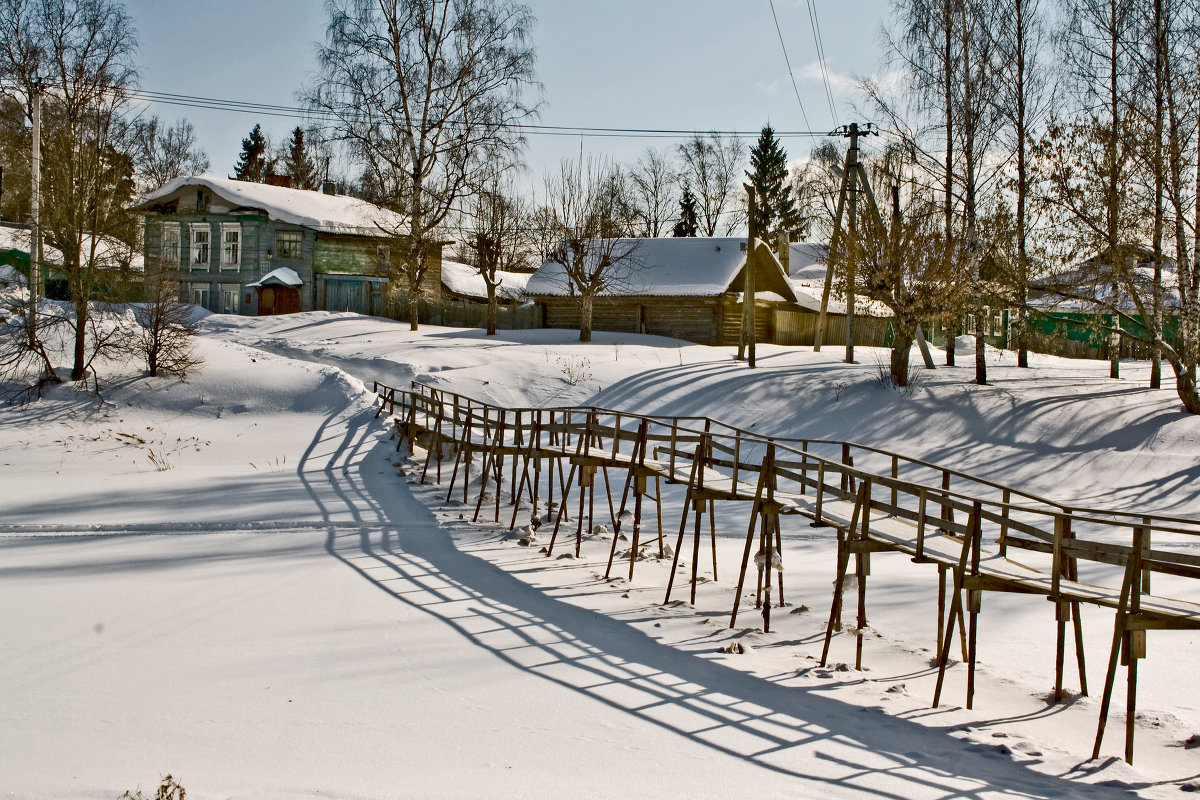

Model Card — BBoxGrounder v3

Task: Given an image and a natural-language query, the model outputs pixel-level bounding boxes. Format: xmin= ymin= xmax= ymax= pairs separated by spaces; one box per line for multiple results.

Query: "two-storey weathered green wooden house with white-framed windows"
xmin=133 ymin=175 xmax=442 ymax=314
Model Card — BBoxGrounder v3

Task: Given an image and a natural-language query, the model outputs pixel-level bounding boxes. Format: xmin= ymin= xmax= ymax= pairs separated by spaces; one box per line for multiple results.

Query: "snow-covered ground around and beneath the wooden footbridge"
xmin=0 ymin=313 xmax=1200 ymax=799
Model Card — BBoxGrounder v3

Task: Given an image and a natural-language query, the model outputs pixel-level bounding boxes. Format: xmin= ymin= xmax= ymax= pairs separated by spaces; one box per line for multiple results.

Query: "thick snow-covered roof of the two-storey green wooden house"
xmin=133 ymin=175 xmax=404 ymax=236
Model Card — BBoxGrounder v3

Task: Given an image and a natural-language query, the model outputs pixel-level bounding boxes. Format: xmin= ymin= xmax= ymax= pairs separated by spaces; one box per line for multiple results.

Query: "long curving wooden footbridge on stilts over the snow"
xmin=374 ymin=381 xmax=1200 ymax=763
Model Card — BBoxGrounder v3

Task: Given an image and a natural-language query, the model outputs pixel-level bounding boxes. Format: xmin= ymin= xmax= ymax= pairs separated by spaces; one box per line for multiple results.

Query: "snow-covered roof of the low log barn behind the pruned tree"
xmin=528 ymin=237 xmax=792 ymax=300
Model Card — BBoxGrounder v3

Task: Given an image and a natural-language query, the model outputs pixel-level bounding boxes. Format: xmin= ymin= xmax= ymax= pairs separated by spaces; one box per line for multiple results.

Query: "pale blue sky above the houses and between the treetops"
xmin=126 ymin=0 xmax=888 ymax=183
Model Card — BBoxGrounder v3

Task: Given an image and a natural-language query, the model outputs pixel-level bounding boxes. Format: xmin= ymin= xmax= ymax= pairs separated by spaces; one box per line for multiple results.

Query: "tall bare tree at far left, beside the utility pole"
xmin=0 ymin=0 xmax=137 ymax=380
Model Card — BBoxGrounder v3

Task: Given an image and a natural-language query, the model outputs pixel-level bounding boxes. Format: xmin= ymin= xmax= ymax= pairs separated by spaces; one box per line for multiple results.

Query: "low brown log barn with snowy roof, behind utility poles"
xmin=527 ymin=237 xmax=797 ymax=345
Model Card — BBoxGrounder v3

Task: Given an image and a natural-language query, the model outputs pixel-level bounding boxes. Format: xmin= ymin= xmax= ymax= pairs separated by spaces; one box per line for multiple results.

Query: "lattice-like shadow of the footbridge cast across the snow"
xmin=309 ymin=444 xmax=1142 ymax=798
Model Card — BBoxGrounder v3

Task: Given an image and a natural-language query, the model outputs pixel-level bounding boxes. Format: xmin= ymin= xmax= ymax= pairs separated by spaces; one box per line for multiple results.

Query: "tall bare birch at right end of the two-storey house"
xmin=302 ymin=0 xmax=538 ymax=330
